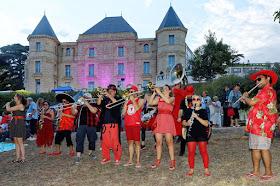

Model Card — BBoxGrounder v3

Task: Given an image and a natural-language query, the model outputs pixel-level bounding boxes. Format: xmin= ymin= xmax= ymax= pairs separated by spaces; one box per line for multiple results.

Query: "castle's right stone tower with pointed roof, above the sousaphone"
xmin=156 ymin=6 xmax=188 ymax=81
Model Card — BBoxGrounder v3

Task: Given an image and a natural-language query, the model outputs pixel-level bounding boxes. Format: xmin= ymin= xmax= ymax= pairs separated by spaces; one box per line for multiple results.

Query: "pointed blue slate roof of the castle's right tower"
xmin=158 ymin=6 xmax=185 ymax=30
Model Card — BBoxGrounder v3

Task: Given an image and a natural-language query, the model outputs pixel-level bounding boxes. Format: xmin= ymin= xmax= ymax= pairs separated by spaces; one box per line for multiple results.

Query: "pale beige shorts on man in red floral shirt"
xmin=249 ymin=133 xmax=271 ymax=150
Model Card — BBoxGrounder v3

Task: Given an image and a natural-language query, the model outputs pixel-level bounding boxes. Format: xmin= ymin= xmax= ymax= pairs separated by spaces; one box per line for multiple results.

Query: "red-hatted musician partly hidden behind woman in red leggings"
xmin=177 ymin=85 xmax=194 ymax=156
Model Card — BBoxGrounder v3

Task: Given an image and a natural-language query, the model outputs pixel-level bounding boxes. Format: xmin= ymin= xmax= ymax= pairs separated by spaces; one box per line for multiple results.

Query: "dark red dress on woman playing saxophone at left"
xmin=36 ymin=113 xmax=54 ymax=147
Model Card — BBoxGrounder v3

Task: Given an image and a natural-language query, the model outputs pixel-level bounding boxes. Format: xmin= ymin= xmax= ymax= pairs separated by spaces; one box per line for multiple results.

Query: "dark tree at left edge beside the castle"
xmin=0 ymin=44 xmax=29 ymax=90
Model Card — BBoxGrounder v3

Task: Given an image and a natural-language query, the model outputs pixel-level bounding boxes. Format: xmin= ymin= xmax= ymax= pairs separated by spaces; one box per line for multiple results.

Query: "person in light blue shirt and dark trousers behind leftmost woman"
xmin=26 ymin=97 xmax=38 ymax=141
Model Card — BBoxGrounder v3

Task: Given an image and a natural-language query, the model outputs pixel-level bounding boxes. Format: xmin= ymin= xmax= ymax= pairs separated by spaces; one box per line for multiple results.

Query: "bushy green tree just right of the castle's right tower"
xmin=190 ymin=31 xmax=244 ymax=82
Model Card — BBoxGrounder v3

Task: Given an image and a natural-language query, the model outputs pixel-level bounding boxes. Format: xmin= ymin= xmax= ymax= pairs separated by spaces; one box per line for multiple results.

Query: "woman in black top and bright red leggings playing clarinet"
xmin=182 ymin=95 xmax=210 ymax=176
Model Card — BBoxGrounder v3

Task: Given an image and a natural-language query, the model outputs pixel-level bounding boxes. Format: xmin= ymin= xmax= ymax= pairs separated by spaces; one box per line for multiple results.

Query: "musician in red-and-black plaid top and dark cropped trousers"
xmin=71 ymin=93 xmax=98 ymax=163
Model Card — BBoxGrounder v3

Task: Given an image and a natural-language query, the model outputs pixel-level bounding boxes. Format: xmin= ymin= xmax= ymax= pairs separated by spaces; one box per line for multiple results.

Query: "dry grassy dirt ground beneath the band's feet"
xmin=0 ymin=127 xmax=280 ymax=186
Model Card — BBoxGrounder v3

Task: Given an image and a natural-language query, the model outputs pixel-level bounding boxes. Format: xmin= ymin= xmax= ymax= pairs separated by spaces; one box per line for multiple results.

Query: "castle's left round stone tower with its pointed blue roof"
xmin=24 ymin=15 xmax=60 ymax=93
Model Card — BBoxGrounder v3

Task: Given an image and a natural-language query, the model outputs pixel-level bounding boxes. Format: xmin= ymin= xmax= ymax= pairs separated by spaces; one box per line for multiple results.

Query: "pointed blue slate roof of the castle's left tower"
xmin=31 ymin=15 xmax=58 ymax=40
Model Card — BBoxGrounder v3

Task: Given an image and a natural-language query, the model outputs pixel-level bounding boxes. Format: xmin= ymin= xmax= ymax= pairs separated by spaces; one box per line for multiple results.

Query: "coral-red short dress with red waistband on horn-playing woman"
xmin=153 ymin=98 xmax=176 ymax=136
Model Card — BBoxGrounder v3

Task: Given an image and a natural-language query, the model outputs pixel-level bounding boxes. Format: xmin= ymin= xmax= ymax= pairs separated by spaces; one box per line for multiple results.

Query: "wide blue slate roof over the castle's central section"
xmin=83 ymin=16 xmax=137 ymax=36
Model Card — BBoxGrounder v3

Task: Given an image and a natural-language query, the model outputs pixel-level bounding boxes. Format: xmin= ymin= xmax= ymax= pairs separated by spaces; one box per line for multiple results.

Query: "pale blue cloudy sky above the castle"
xmin=0 ymin=0 xmax=280 ymax=63
